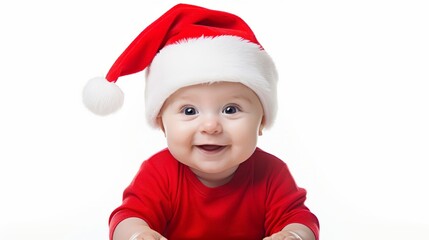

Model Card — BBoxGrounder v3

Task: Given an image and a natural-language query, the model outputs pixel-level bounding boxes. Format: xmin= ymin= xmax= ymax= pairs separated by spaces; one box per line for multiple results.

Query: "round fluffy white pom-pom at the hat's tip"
xmin=82 ymin=77 xmax=124 ymax=116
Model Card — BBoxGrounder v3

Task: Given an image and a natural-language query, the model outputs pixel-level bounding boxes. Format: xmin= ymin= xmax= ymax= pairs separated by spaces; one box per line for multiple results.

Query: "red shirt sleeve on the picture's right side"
xmin=265 ymin=158 xmax=319 ymax=239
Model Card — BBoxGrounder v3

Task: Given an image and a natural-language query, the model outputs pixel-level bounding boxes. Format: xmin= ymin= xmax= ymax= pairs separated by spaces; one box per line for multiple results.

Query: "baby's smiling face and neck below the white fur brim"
xmin=158 ymin=82 xmax=263 ymax=186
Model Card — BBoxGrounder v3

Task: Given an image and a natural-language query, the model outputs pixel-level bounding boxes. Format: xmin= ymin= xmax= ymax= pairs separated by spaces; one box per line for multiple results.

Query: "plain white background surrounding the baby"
xmin=0 ymin=0 xmax=429 ymax=240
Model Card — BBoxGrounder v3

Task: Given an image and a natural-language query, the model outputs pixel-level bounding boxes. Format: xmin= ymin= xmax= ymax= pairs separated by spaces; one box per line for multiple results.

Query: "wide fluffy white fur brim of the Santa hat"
xmin=145 ymin=36 xmax=277 ymax=127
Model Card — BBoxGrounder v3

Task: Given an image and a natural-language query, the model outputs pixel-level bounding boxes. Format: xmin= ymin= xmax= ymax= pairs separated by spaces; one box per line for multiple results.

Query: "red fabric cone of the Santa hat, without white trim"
xmin=106 ymin=4 xmax=259 ymax=82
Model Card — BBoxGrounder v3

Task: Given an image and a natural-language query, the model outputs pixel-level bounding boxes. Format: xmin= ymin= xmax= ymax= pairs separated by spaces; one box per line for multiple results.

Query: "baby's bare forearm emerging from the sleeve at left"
xmin=113 ymin=217 xmax=167 ymax=240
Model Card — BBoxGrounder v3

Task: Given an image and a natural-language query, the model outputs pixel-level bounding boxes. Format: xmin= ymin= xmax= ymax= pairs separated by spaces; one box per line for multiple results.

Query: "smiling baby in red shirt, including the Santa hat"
xmin=83 ymin=4 xmax=319 ymax=240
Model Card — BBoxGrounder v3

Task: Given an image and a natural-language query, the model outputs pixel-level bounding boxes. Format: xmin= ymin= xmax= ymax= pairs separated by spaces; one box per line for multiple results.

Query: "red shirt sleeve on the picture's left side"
xmin=109 ymin=155 xmax=176 ymax=239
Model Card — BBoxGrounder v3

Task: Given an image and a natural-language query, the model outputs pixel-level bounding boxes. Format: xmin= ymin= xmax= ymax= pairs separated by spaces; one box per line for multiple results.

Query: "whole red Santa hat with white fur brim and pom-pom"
xmin=83 ymin=4 xmax=277 ymax=127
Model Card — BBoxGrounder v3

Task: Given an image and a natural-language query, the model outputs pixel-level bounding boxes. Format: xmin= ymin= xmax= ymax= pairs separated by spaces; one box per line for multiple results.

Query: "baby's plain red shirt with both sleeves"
xmin=109 ymin=149 xmax=319 ymax=240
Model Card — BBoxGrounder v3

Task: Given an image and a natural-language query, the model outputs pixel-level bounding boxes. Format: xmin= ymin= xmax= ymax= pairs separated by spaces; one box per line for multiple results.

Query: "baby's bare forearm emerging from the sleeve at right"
xmin=263 ymin=223 xmax=315 ymax=240
